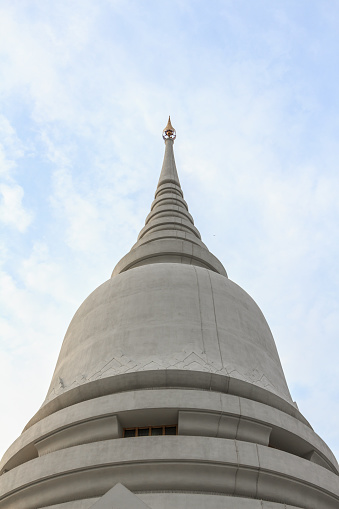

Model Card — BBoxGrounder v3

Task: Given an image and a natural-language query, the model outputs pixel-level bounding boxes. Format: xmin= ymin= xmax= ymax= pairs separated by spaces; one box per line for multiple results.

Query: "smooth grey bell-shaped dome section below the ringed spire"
xmin=45 ymin=263 xmax=292 ymax=403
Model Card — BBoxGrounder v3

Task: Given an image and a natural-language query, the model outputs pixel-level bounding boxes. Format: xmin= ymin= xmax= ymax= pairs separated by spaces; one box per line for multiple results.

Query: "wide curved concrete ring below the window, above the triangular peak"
xmin=0 ymin=436 xmax=339 ymax=509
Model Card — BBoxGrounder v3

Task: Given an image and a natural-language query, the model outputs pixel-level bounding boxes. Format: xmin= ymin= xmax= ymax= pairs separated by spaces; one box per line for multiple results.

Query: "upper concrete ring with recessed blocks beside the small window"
xmin=0 ymin=389 xmax=338 ymax=472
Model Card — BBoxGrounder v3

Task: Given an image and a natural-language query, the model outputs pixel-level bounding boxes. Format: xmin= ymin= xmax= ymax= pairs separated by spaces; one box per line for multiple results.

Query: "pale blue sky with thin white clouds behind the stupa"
xmin=0 ymin=0 xmax=339 ymax=458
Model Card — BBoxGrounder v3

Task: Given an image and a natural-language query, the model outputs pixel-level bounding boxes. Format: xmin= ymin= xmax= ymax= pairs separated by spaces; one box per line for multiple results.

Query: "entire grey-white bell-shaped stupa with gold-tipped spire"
xmin=0 ymin=120 xmax=339 ymax=509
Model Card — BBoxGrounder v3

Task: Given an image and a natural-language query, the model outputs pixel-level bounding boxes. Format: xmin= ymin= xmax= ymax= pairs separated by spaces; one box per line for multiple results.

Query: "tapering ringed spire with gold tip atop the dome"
xmin=112 ymin=117 xmax=227 ymax=277
